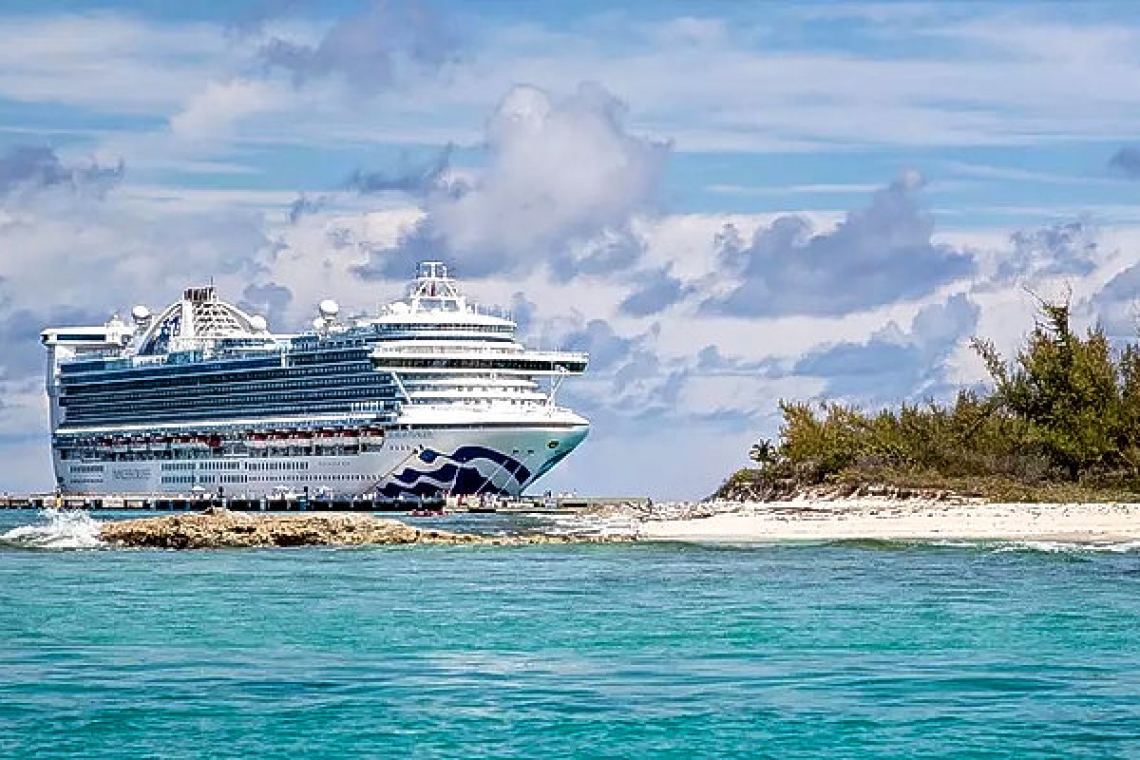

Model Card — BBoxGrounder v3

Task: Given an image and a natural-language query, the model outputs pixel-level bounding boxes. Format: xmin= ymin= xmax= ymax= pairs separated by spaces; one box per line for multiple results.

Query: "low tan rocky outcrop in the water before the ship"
xmin=99 ymin=508 xmax=634 ymax=549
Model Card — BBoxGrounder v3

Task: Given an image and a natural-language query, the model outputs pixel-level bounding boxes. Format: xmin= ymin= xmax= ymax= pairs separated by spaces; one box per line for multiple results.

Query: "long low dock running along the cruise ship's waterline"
xmin=0 ymin=493 xmax=650 ymax=514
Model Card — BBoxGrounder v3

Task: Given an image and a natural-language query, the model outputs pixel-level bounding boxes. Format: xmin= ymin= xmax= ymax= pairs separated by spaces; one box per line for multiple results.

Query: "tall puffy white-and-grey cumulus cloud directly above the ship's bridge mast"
xmin=358 ymin=83 xmax=669 ymax=278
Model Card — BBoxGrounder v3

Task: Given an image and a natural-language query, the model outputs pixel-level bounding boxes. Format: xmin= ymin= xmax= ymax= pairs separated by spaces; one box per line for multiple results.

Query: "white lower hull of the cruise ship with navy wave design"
xmin=55 ymin=418 xmax=589 ymax=498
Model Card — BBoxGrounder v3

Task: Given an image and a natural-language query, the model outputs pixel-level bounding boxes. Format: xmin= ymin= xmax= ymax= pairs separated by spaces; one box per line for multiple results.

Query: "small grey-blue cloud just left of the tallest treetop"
xmin=791 ymin=293 xmax=982 ymax=404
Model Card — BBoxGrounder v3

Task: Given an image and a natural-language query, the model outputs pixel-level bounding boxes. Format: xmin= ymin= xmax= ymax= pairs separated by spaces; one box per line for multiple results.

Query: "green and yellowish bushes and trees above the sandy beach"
xmin=717 ymin=302 xmax=1140 ymax=501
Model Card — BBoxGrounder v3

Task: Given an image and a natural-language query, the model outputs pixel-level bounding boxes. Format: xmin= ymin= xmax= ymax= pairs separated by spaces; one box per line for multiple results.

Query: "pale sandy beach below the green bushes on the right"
xmin=638 ymin=499 xmax=1140 ymax=544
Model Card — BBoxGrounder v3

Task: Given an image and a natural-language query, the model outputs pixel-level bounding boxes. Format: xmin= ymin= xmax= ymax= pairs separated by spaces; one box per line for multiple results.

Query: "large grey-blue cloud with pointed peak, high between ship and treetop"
xmin=702 ymin=172 xmax=975 ymax=317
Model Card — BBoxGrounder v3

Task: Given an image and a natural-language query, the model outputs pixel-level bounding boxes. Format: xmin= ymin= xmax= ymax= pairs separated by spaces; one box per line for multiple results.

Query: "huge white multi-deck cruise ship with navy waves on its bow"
xmin=41 ymin=262 xmax=589 ymax=499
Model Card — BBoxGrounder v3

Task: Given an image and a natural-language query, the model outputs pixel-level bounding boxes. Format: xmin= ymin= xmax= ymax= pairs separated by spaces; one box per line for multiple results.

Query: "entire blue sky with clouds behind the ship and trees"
xmin=0 ymin=0 xmax=1140 ymax=499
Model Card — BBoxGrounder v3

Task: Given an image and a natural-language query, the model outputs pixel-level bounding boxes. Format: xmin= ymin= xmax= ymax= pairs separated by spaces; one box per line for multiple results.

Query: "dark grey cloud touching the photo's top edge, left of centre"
xmin=259 ymin=0 xmax=459 ymax=92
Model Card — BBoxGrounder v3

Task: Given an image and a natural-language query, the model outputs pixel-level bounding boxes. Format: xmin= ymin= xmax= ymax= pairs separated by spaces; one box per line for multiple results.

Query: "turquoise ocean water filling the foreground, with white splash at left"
xmin=0 ymin=512 xmax=1140 ymax=760
